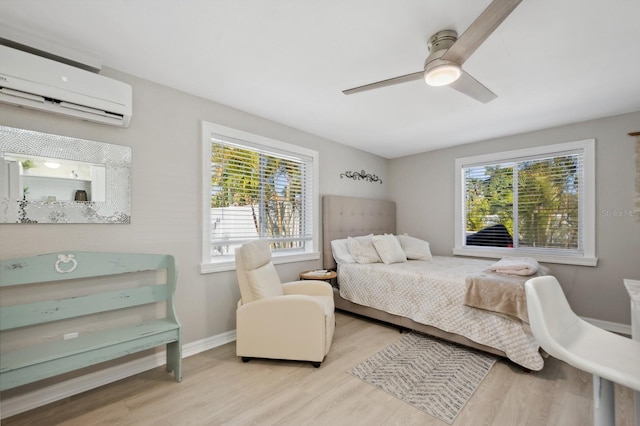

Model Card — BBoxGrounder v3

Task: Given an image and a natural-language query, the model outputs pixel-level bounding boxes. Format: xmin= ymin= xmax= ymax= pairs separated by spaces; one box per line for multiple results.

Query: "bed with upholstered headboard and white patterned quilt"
xmin=322 ymin=195 xmax=548 ymax=371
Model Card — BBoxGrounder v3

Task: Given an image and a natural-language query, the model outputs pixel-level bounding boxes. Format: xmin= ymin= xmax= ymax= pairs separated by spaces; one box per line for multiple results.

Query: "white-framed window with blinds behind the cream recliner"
xmin=201 ymin=122 xmax=319 ymax=272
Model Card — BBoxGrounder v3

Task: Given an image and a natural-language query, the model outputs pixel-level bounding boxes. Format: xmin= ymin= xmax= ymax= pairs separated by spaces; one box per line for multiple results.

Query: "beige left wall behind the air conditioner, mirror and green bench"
xmin=0 ymin=66 xmax=389 ymax=343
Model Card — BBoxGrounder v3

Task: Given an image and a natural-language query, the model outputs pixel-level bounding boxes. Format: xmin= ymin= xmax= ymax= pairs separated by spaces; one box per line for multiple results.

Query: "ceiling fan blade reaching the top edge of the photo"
xmin=441 ymin=0 xmax=522 ymax=65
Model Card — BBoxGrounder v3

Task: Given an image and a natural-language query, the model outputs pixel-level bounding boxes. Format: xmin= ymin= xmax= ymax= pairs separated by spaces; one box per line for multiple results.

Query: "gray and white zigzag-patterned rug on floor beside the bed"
xmin=348 ymin=332 xmax=497 ymax=424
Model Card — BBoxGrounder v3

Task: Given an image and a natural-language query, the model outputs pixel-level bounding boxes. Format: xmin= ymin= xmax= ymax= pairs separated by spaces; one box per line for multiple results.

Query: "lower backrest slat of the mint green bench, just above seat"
xmin=0 ymin=284 xmax=172 ymax=330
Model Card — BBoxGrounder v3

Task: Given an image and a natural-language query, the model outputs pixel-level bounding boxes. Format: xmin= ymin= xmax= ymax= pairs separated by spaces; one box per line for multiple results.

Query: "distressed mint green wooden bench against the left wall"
xmin=0 ymin=252 xmax=182 ymax=390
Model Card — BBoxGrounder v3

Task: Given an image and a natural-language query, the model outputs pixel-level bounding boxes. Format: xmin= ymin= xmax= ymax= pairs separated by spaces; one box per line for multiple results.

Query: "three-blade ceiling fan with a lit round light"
xmin=342 ymin=0 xmax=522 ymax=103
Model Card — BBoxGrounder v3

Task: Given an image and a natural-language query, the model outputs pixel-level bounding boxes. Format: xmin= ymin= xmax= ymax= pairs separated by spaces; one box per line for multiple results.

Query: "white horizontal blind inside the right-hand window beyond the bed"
xmin=464 ymin=153 xmax=583 ymax=253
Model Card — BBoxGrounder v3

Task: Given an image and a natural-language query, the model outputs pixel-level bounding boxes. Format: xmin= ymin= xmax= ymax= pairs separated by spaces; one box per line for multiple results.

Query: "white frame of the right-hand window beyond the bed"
xmin=453 ymin=139 xmax=598 ymax=266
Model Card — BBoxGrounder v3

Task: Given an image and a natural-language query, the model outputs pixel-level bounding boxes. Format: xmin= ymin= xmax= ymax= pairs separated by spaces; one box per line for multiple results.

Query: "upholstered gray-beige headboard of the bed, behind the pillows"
xmin=322 ymin=195 xmax=396 ymax=269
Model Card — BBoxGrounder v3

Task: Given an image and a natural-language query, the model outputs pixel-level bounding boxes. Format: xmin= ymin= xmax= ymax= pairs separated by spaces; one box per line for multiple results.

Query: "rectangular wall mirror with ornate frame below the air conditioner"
xmin=0 ymin=126 xmax=131 ymax=223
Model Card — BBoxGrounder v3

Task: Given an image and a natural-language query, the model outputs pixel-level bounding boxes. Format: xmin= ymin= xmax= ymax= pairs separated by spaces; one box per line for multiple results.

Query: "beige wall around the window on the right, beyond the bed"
xmin=389 ymin=112 xmax=640 ymax=324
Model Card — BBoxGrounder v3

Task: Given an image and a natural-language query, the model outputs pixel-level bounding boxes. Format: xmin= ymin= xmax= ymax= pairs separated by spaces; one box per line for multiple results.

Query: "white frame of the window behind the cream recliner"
xmin=200 ymin=120 xmax=320 ymax=274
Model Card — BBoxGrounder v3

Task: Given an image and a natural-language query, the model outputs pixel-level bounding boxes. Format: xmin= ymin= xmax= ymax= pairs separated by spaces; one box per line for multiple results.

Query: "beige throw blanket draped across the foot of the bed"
xmin=464 ymin=266 xmax=549 ymax=324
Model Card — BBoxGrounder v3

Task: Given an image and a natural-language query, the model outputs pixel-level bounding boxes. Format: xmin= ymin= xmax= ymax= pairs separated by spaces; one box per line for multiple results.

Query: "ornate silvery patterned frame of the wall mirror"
xmin=0 ymin=126 xmax=131 ymax=224
